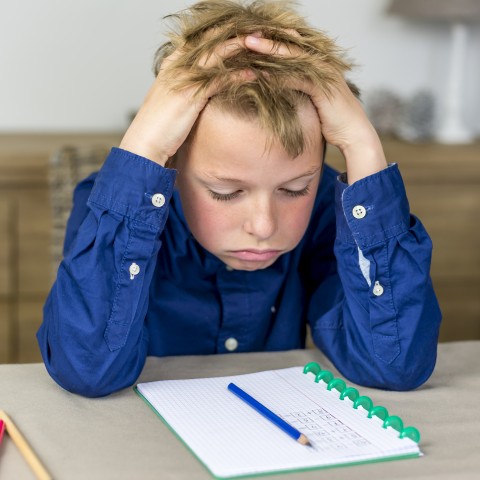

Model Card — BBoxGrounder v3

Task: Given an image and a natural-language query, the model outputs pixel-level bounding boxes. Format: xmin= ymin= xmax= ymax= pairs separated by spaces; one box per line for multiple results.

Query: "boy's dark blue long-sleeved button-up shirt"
xmin=37 ymin=148 xmax=441 ymax=396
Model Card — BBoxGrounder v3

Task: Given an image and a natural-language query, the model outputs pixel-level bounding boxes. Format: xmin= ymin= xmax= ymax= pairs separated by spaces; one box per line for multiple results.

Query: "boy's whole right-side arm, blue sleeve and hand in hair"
xmin=245 ymin=36 xmax=441 ymax=390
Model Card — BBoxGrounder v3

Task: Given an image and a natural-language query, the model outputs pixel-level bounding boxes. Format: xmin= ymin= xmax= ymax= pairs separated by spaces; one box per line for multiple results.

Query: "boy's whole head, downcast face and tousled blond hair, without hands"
xmin=155 ymin=0 xmax=349 ymax=271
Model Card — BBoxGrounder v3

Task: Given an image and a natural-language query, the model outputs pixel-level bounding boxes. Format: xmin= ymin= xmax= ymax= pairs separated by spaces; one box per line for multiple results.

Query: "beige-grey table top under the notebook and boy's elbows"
xmin=0 ymin=341 xmax=480 ymax=480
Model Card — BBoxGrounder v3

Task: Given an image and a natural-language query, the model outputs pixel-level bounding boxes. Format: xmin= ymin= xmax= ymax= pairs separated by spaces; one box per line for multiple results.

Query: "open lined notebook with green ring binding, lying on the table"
xmin=135 ymin=363 xmax=422 ymax=478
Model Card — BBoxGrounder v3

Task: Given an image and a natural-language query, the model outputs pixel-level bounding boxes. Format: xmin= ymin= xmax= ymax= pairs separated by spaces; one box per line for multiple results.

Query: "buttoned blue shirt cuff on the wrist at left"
xmin=88 ymin=148 xmax=177 ymax=229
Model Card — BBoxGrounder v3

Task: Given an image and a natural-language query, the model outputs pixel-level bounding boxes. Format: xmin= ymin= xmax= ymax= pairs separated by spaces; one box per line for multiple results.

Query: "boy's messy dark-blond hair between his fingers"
xmin=154 ymin=0 xmax=358 ymax=157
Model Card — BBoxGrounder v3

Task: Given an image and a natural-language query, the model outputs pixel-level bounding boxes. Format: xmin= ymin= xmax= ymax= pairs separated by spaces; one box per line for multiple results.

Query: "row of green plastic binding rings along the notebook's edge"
xmin=303 ymin=362 xmax=420 ymax=443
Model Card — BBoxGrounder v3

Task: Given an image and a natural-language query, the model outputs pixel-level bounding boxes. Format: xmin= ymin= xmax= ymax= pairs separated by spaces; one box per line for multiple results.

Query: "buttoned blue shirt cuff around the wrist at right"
xmin=335 ymin=164 xmax=410 ymax=248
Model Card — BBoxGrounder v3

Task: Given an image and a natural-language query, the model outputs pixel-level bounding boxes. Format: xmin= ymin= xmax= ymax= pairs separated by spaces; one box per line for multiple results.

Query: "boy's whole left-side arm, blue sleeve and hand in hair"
xmin=38 ymin=39 xmax=255 ymax=396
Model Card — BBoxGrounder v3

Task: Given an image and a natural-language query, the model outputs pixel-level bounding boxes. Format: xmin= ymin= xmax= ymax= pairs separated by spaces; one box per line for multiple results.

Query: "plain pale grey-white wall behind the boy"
xmin=0 ymin=0 xmax=480 ymax=133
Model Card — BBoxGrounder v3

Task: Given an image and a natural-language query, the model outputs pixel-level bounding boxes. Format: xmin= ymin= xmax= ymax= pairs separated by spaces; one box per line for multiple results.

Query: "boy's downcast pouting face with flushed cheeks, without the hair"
xmin=176 ymin=104 xmax=323 ymax=270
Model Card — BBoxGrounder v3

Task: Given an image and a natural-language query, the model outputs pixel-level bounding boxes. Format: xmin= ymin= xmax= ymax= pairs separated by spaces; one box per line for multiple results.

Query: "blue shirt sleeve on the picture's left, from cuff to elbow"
xmin=37 ymin=148 xmax=176 ymax=396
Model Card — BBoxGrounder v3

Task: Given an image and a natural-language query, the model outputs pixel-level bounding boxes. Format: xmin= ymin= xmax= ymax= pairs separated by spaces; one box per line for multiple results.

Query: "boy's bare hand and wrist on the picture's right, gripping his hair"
xmin=245 ymin=36 xmax=387 ymax=184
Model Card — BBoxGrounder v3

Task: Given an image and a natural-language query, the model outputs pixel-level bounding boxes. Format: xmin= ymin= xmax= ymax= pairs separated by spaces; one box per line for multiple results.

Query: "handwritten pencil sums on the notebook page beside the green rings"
xmin=283 ymin=407 xmax=371 ymax=451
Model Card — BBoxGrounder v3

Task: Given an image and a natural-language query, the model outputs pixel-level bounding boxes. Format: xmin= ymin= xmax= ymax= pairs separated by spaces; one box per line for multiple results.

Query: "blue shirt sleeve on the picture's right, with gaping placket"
xmin=308 ymin=165 xmax=441 ymax=390
